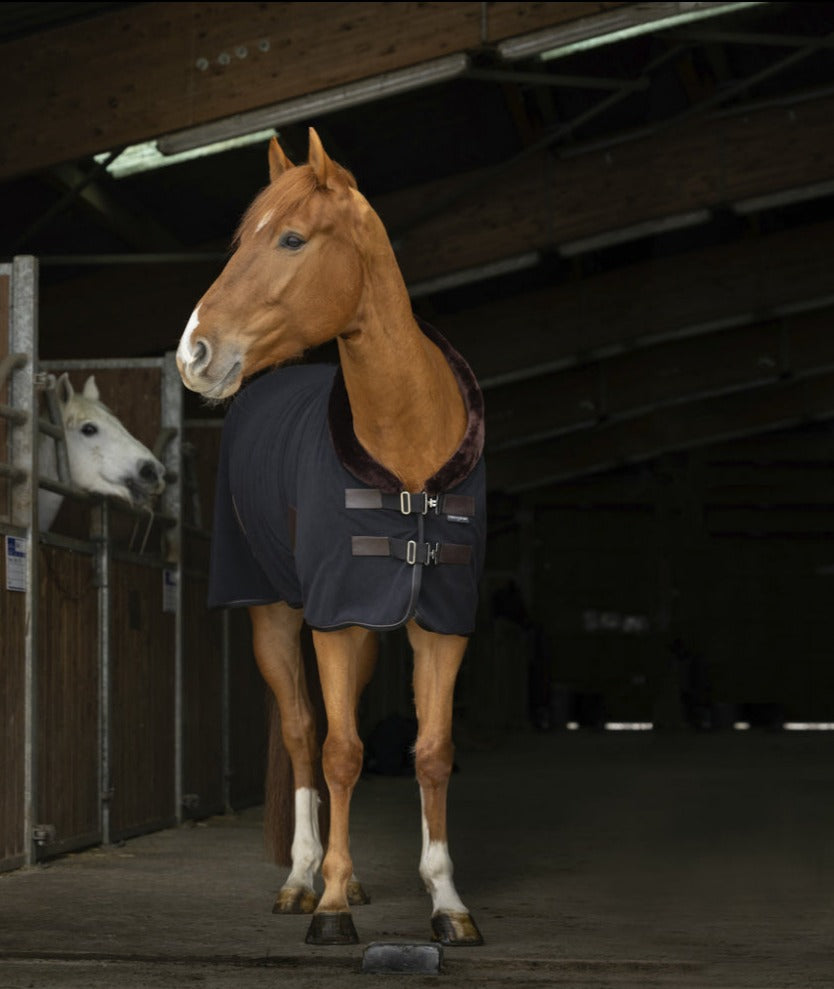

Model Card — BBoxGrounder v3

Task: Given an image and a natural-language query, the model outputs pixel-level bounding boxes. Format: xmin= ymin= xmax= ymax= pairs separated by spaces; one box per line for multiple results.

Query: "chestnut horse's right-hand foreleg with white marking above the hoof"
xmin=408 ymin=622 xmax=483 ymax=945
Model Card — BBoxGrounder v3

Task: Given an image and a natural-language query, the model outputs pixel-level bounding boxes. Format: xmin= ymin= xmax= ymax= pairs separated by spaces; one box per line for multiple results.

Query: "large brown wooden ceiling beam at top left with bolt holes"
xmin=0 ymin=2 xmax=629 ymax=179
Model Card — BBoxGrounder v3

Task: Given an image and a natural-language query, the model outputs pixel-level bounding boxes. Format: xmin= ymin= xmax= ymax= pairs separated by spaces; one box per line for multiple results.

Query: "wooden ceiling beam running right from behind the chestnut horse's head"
xmin=374 ymin=89 xmax=834 ymax=282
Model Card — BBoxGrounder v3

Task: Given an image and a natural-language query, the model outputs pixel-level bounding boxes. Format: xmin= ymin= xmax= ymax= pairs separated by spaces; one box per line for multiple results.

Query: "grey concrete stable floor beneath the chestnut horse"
xmin=0 ymin=731 xmax=834 ymax=989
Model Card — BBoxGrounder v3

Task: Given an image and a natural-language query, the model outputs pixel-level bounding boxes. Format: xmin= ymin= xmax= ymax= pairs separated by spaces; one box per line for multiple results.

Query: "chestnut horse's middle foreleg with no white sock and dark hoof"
xmin=306 ymin=627 xmax=375 ymax=944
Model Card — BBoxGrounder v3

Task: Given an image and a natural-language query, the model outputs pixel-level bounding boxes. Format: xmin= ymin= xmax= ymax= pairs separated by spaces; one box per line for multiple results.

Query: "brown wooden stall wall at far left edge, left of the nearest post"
xmin=0 ymin=266 xmax=26 ymax=869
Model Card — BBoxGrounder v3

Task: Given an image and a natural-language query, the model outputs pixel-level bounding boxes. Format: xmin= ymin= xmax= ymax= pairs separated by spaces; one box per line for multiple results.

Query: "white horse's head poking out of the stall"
xmin=56 ymin=374 xmax=165 ymax=508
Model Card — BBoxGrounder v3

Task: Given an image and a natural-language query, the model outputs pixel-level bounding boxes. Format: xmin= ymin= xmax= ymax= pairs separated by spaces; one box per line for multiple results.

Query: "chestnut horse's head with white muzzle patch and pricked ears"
xmin=177 ymin=128 xmax=390 ymax=399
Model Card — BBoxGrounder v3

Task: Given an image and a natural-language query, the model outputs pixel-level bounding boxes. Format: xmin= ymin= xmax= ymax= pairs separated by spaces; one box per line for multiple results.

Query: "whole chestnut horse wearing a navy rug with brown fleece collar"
xmin=177 ymin=129 xmax=485 ymax=945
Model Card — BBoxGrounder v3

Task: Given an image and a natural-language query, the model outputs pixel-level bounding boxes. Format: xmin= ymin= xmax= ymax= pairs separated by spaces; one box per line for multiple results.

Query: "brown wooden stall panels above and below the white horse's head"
xmin=38 ymin=362 xmax=177 ymax=854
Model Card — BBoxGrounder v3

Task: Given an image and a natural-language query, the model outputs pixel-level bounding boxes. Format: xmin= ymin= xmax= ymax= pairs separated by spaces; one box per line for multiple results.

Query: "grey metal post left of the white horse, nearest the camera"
xmin=9 ymin=256 xmax=38 ymax=865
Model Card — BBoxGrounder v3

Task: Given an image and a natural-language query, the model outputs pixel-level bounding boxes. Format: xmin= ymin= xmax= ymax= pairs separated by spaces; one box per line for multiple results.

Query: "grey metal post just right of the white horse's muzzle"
xmin=162 ymin=353 xmax=185 ymax=823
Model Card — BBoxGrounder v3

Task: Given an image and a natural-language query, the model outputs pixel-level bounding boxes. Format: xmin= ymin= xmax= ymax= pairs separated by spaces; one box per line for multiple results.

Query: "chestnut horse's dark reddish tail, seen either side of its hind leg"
xmin=264 ymin=626 xmax=330 ymax=866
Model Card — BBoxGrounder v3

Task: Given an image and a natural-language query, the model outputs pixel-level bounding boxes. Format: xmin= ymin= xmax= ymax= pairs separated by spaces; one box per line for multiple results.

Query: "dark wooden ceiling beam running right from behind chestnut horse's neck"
xmin=438 ymin=223 xmax=834 ymax=387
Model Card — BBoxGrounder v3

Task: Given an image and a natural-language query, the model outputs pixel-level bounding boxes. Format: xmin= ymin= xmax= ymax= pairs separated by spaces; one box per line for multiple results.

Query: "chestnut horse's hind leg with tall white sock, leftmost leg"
xmin=249 ymin=602 xmax=322 ymax=913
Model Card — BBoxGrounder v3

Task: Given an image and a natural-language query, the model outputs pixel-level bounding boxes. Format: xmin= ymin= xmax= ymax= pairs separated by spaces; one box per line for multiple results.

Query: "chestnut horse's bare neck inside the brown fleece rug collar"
xmin=339 ymin=308 xmax=467 ymax=491
